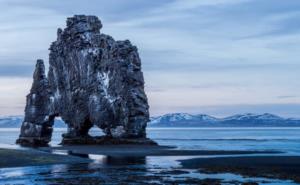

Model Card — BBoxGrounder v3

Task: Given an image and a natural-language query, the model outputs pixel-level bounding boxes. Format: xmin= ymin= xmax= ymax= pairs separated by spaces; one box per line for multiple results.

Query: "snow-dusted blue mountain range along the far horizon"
xmin=0 ymin=113 xmax=300 ymax=128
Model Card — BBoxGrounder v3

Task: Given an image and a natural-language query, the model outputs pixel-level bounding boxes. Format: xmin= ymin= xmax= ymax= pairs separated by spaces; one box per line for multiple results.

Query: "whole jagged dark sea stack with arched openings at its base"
xmin=17 ymin=15 xmax=154 ymax=146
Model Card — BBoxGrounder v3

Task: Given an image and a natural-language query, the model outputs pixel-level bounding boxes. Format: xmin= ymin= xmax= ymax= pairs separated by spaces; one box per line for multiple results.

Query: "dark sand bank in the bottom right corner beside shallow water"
xmin=181 ymin=156 xmax=300 ymax=183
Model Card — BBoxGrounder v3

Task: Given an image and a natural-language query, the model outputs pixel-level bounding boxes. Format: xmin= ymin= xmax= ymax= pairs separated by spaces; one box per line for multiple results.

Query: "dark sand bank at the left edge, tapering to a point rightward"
xmin=0 ymin=149 xmax=91 ymax=168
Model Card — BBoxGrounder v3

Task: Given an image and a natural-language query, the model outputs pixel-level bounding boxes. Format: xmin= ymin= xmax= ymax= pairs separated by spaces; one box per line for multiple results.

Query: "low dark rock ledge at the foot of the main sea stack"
xmin=60 ymin=136 xmax=158 ymax=145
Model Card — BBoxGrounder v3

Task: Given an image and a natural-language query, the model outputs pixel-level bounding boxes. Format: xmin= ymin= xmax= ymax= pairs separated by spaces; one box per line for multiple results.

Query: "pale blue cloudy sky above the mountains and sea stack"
xmin=0 ymin=0 xmax=300 ymax=118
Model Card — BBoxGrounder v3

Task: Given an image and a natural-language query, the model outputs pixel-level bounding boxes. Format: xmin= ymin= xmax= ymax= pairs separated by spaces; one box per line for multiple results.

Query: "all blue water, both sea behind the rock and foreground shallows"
xmin=0 ymin=128 xmax=300 ymax=185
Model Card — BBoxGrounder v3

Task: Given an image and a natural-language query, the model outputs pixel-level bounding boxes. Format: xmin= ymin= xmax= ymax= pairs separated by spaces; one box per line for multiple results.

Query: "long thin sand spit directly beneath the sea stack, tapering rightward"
xmin=40 ymin=145 xmax=282 ymax=156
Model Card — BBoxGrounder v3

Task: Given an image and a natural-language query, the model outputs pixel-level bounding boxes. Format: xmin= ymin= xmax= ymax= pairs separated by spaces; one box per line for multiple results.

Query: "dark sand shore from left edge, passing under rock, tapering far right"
xmin=0 ymin=145 xmax=281 ymax=168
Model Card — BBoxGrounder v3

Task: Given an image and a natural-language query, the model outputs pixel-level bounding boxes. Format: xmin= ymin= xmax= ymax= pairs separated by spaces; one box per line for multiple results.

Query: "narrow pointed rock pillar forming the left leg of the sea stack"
xmin=17 ymin=60 xmax=54 ymax=146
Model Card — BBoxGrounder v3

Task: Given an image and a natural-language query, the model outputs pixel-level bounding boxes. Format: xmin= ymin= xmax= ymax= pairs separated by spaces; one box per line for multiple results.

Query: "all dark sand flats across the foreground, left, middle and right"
xmin=0 ymin=145 xmax=300 ymax=185
